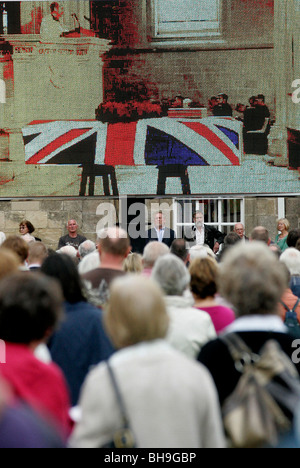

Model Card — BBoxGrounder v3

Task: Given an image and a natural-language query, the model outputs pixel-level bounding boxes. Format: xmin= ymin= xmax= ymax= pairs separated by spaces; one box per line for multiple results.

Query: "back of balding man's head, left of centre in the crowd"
xmin=98 ymin=227 xmax=131 ymax=268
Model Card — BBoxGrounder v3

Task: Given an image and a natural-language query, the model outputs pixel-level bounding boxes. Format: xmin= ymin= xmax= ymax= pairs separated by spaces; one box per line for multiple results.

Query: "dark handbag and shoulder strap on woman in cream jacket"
xmin=101 ymin=361 xmax=136 ymax=448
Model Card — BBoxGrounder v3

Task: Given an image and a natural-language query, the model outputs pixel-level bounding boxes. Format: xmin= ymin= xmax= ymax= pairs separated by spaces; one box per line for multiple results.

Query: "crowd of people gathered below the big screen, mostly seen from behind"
xmin=0 ymin=211 xmax=300 ymax=448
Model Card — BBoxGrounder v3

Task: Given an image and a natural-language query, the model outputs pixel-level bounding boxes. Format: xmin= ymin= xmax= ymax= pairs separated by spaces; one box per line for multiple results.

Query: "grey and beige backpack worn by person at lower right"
xmin=220 ymin=333 xmax=300 ymax=448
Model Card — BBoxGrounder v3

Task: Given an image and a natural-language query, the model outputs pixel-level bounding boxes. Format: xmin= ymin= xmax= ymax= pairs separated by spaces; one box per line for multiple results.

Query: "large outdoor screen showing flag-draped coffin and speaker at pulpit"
xmin=0 ymin=0 xmax=300 ymax=198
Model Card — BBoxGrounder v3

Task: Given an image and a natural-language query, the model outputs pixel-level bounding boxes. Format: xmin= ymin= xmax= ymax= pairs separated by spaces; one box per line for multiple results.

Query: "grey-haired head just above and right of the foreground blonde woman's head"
xmin=151 ymin=253 xmax=190 ymax=296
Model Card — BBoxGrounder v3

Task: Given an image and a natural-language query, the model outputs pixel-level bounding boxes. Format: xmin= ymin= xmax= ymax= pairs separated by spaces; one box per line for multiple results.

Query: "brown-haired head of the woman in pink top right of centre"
xmin=189 ymin=257 xmax=219 ymax=299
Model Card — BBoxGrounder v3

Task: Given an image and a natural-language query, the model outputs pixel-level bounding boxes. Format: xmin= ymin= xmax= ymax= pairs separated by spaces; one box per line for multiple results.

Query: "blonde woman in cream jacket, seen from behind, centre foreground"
xmin=69 ymin=276 xmax=225 ymax=448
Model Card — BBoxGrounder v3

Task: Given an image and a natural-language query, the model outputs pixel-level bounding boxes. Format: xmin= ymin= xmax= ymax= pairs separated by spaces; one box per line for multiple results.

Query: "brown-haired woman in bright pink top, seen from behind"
xmin=189 ymin=257 xmax=235 ymax=334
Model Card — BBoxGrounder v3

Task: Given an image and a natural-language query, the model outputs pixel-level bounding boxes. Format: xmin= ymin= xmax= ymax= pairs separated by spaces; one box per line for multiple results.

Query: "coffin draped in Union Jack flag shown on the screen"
xmin=22 ymin=117 xmax=243 ymax=167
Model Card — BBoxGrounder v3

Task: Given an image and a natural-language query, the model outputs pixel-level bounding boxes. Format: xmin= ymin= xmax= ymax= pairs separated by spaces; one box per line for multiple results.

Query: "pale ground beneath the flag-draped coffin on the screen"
xmin=0 ymin=150 xmax=300 ymax=198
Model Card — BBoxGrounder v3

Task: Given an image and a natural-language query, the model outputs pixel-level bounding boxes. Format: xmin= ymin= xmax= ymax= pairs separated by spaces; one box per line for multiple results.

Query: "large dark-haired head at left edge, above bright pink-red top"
xmin=0 ymin=272 xmax=63 ymax=345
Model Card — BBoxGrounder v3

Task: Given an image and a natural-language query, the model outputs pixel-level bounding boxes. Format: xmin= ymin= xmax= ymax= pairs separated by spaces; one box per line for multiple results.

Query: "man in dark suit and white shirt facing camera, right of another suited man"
xmin=184 ymin=210 xmax=225 ymax=253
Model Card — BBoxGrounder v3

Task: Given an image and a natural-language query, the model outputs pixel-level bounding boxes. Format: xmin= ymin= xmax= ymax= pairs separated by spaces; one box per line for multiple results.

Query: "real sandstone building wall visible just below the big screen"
xmin=0 ymin=197 xmax=300 ymax=249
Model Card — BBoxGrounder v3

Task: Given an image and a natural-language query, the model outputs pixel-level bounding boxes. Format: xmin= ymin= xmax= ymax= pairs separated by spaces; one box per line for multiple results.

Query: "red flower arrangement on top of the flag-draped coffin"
xmin=96 ymin=101 xmax=163 ymax=122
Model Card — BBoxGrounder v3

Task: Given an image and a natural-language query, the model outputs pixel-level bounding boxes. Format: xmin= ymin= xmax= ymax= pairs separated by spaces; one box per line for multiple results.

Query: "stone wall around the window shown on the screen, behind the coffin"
xmin=104 ymin=0 xmax=275 ymax=116
